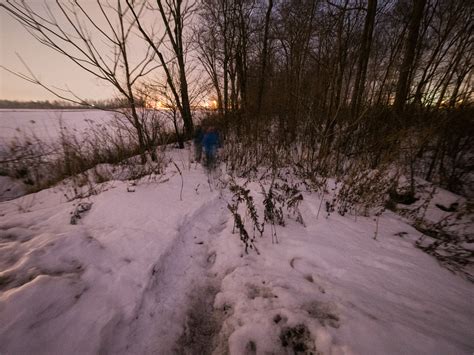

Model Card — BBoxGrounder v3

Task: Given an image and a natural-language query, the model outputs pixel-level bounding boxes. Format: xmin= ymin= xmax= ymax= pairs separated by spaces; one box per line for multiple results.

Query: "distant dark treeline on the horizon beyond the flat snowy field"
xmin=0 ymin=99 xmax=131 ymax=109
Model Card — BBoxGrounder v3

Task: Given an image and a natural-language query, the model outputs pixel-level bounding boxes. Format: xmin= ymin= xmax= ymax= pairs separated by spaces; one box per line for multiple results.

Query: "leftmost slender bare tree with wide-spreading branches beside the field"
xmin=0 ymin=0 xmax=157 ymax=162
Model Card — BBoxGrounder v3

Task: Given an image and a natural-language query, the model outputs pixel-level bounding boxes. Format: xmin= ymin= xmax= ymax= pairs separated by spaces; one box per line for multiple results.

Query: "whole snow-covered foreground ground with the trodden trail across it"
xmin=0 ymin=151 xmax=474 ymax=354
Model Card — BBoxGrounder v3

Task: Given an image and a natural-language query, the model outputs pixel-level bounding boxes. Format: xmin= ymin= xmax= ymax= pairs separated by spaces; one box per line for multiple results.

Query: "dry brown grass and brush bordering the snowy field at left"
xmin=0 ymin=114 xmax=164 ymax=196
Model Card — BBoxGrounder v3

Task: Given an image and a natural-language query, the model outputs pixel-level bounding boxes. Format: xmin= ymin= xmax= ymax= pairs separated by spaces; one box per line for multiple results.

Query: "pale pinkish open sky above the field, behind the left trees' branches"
xmin=0 ymin=0 xmax=202 ymax=101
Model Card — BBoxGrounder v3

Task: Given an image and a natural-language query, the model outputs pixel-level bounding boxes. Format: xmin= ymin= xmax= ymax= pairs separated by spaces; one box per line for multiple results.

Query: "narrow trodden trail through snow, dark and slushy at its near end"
xmin=105 ymin=198 xmax=227 ymax=354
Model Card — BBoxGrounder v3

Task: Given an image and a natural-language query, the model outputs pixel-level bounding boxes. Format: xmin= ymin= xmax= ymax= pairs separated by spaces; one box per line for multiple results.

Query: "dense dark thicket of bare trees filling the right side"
xmin=196 ymin=0 xmax=474 ymax=195
